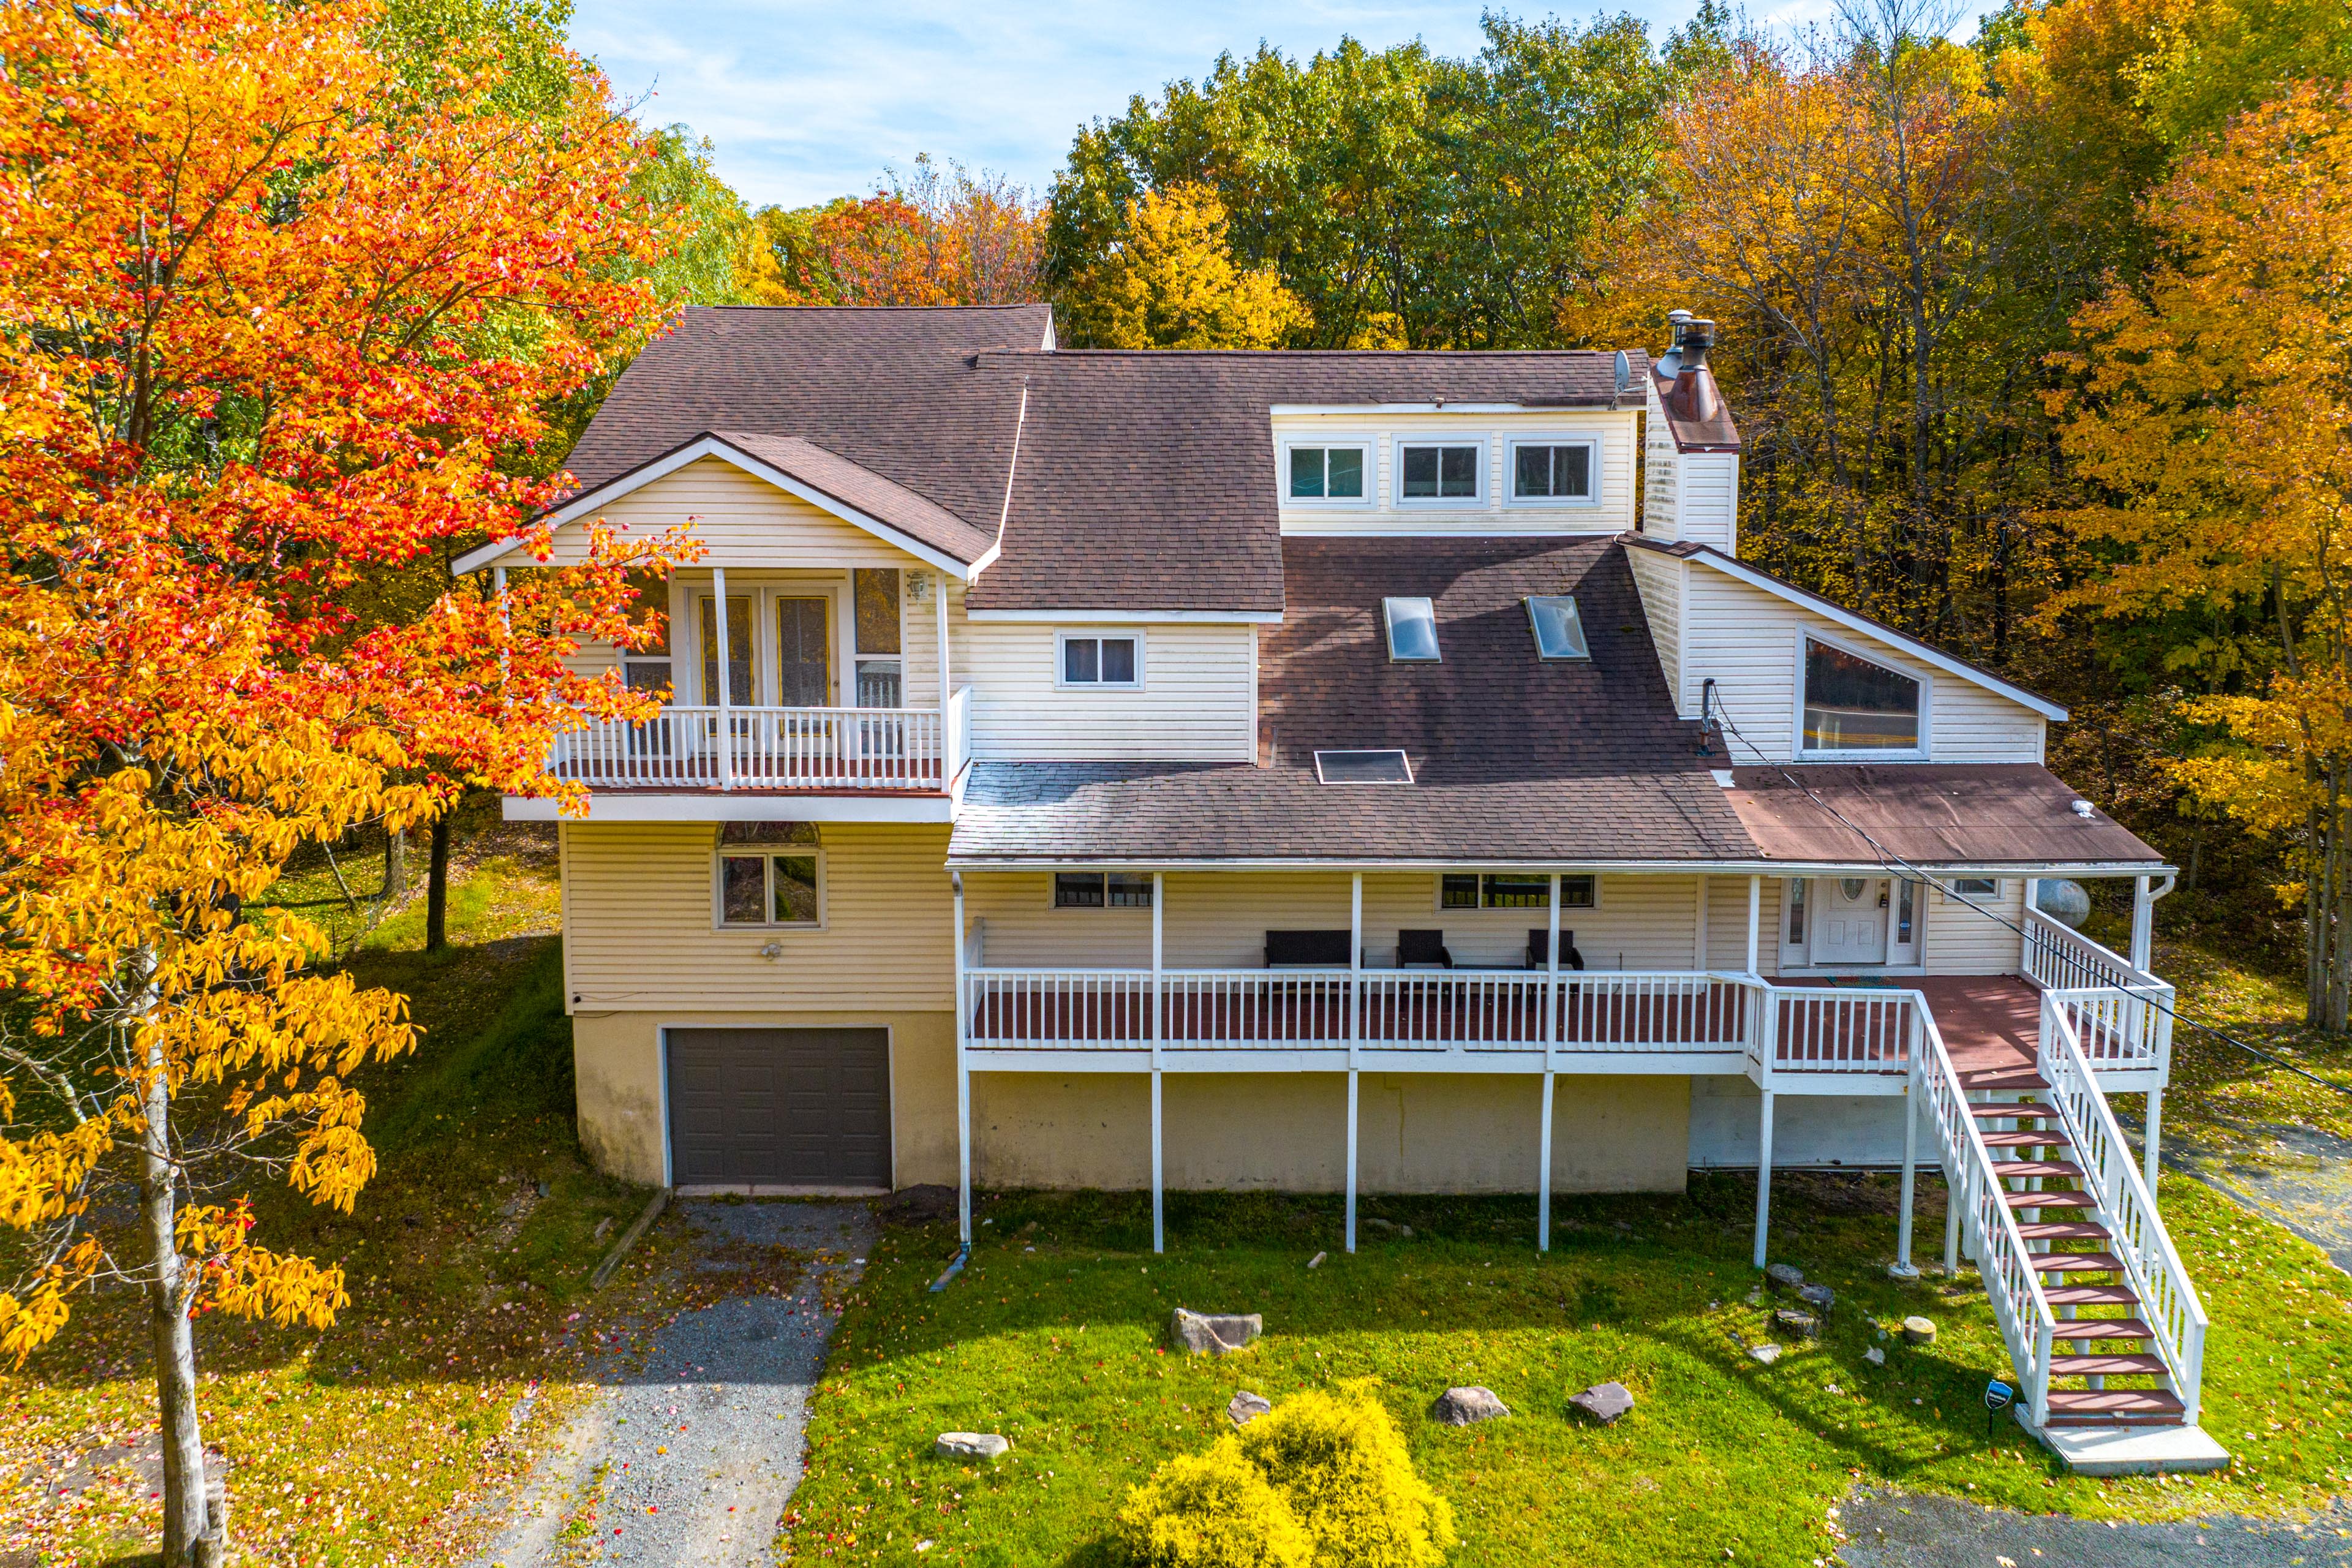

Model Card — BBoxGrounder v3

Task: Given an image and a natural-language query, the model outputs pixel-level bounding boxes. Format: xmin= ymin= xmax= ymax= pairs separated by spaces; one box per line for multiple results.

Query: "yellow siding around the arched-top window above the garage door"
xmin=562 ymin=823 xmax=955 ymax=1013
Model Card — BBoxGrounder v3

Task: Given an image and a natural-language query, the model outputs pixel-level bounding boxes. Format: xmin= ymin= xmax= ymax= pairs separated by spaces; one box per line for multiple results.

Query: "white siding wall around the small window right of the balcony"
xmin=950 ymin=620 xmax=1258 ymax=762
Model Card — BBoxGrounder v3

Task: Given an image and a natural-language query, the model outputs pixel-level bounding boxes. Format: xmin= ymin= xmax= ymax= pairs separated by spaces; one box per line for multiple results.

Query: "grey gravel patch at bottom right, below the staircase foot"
xmin=1837 ymin=1488 xmax=2352 ymax=1568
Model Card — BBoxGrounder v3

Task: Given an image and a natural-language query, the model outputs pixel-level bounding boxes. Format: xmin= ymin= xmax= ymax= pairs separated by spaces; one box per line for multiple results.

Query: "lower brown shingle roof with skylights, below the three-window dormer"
xmin=950 ymin=538 xmax=1752 ymax=865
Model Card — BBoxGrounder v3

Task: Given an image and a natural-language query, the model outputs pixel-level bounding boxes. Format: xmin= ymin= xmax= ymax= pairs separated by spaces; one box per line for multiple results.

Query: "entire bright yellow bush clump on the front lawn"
xmin=1117 ymin=1389 xmax=1453 ymax=1568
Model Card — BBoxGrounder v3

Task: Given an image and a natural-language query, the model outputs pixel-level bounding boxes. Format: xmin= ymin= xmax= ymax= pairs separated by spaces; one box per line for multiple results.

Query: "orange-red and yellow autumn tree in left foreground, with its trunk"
xmin=0 ymin=0 xmax=682 ymax=1568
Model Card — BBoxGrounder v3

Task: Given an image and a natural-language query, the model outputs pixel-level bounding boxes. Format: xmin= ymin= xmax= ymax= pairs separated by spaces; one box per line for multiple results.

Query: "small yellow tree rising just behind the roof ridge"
xmin=1072 ymin=181 xmax=1313 ymax=348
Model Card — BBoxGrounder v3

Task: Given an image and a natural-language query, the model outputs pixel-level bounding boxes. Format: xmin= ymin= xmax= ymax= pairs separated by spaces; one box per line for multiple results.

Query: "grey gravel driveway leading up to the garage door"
xmin=475 ymin=1201 xmax=875 ymax=1568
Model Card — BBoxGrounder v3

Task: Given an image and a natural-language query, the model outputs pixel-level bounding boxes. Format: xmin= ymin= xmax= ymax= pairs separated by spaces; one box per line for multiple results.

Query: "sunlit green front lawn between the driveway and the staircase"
xmin=786 ymin=1178 xmax=2352 ymax=1568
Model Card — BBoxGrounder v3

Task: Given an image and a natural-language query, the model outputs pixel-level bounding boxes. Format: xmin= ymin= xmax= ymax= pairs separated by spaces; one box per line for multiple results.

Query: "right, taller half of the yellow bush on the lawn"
xmin=1240 ymin=1392 xmax=1453 ymax=1568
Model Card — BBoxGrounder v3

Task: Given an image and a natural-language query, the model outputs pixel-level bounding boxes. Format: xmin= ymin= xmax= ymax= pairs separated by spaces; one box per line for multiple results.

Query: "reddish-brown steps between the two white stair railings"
xmin=1959 ymin=1067 xmax=2185 ymax=1427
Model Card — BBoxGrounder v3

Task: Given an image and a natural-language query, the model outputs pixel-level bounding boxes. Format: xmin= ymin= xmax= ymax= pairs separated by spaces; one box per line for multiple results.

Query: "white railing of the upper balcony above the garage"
xmin=548 ymin=705 xmax=945 ymax=792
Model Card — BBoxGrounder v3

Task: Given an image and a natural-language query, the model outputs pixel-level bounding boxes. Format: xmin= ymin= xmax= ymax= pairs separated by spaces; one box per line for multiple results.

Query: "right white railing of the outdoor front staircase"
xmin=2039 ymin=992 xmax=2206 ymax=1427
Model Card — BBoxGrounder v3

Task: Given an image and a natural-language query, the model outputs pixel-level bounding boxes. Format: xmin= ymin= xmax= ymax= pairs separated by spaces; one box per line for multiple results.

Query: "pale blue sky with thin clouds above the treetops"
xmin=571 ymin=0 xmax=1796 ymax=207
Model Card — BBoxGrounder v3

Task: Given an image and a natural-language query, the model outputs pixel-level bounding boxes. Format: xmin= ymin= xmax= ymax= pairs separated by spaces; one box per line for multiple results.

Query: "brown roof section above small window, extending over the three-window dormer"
xmin=969 ymin=350 xmax=1649 ymax=614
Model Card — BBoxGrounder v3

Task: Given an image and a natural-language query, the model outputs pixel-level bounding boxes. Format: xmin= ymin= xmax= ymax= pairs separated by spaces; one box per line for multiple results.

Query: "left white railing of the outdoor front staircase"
xmin=1910 ymin=999 xmax=2058 ymax=1431
